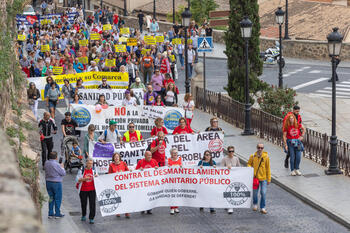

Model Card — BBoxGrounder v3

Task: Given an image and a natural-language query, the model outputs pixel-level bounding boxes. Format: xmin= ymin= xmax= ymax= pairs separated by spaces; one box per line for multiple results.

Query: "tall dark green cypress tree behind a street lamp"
xmin=225 ymin=0 xmax=268 ymax=104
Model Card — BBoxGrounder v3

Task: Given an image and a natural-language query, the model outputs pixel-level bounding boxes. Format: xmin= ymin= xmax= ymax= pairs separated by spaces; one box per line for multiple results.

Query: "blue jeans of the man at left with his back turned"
xmin=46 ymin=181 xmax=62 ymax=216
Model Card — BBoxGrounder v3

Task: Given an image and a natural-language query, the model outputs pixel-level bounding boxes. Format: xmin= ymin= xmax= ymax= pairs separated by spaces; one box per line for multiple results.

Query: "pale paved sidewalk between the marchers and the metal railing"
xmin=191 ymin=109 xmax=350 ymax=228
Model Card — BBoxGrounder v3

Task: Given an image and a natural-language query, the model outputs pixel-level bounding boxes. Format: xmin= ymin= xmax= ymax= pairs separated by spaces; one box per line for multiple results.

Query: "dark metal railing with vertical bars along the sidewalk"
xmin=195 ymin=87 xmax=350 ymax=176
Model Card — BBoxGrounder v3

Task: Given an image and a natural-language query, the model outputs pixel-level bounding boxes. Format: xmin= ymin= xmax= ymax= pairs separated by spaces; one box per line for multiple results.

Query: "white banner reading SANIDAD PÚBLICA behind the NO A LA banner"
xmin=78 ymin=88 xmax=144 ymax=106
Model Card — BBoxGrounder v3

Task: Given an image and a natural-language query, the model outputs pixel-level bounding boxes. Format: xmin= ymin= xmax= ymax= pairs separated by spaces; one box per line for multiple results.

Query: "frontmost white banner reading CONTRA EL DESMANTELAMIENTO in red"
xmin=95 ymin=167 xmax=253 ymax=216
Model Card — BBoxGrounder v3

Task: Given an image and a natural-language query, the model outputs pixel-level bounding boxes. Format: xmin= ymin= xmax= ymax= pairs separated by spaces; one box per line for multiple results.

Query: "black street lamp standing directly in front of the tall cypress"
xmin=240 ymin=16 xmax=254 ymax=135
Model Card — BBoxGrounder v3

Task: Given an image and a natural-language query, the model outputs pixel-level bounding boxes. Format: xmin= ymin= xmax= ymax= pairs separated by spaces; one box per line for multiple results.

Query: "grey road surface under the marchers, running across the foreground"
xmin=39 ymin=106 xmax=348 ymax=233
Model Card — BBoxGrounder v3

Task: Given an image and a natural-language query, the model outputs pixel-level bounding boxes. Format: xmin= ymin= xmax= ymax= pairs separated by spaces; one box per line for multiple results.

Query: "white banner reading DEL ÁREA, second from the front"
xmin=89 ymin=132 xmax=224 ymax=173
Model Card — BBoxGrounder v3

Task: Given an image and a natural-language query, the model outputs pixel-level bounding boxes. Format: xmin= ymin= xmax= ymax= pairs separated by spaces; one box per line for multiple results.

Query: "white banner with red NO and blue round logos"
xmin=72 ymin=104 xmax=185 ymax=132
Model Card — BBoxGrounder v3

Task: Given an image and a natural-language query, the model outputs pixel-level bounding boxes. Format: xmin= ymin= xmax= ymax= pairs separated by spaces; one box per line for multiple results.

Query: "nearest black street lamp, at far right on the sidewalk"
xmin=325 ymin=28 xmax=343 ymax=175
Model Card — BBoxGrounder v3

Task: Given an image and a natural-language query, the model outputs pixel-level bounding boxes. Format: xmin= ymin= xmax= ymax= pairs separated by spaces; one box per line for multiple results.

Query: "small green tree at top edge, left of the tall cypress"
xmin=191 ymin=0 xmax=218 ymax=24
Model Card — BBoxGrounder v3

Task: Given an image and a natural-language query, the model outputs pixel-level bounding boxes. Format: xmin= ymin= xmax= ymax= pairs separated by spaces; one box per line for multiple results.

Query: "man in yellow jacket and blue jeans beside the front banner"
xmin=248 ymin=143 xmax=271 ymax=214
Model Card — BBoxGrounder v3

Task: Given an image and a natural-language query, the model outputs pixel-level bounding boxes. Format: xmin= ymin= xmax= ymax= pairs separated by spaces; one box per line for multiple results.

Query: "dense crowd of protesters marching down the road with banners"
xmin=23 ymin=4 xmax=274 ymax=224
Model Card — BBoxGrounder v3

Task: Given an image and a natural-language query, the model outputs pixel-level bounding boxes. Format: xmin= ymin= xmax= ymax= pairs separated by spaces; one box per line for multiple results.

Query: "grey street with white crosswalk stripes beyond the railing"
xmin=178 ymin=58 xmax=350 ymax=99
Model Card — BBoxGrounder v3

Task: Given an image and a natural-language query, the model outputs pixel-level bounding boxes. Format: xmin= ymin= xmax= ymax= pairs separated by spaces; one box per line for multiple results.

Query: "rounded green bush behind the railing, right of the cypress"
xmin=258 ymin=86 xmax=298 ymax=117
